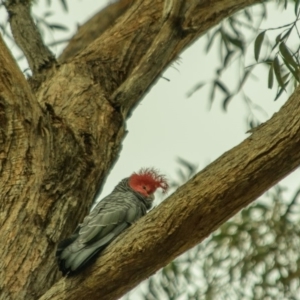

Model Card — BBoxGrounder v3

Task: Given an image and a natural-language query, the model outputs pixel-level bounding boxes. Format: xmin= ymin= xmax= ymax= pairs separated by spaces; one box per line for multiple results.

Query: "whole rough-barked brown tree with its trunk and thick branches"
xmin=0 ymin=0 xmax=300 ymax=299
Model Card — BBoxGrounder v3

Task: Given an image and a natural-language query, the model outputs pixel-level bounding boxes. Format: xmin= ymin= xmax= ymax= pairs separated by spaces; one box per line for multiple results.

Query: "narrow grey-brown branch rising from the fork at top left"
xmin=4 ymin=0 xmax=55 ymax=74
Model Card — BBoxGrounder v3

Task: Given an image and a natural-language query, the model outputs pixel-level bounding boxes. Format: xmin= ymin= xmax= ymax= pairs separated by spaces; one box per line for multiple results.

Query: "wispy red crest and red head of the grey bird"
xmin=129 ymin=168 xmax=169 ymax=194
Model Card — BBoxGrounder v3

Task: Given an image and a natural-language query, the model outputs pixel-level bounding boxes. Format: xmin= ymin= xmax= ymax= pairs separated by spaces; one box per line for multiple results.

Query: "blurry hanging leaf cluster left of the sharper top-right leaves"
xmin=187 ymin=4 xmax=266 ymax=111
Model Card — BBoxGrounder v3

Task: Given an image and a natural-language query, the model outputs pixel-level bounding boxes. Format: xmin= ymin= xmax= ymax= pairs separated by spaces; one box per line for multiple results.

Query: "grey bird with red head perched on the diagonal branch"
xmin=56 ymin=168 xmax=169 ymax=276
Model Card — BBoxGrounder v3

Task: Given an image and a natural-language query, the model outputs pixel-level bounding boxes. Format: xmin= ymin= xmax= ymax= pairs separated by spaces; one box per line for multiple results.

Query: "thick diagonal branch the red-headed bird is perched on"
xmin=40 ymin=84 xmax=300 ymax=300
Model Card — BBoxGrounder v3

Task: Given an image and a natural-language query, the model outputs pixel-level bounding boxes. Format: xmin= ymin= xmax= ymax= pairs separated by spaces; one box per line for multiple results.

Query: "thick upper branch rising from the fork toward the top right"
xmin=75 ymin=0 xmax=260 ymax=119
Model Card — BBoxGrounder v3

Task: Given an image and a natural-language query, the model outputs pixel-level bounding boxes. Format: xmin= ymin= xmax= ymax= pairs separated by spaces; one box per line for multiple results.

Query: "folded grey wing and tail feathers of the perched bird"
xmin=60 ymin=192 xmax=143 ymax=273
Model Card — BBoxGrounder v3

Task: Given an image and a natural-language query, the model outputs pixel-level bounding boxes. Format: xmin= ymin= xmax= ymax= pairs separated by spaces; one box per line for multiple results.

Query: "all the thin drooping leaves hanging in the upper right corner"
xmin=187 ymin=0 xmax=300 ymax=128
